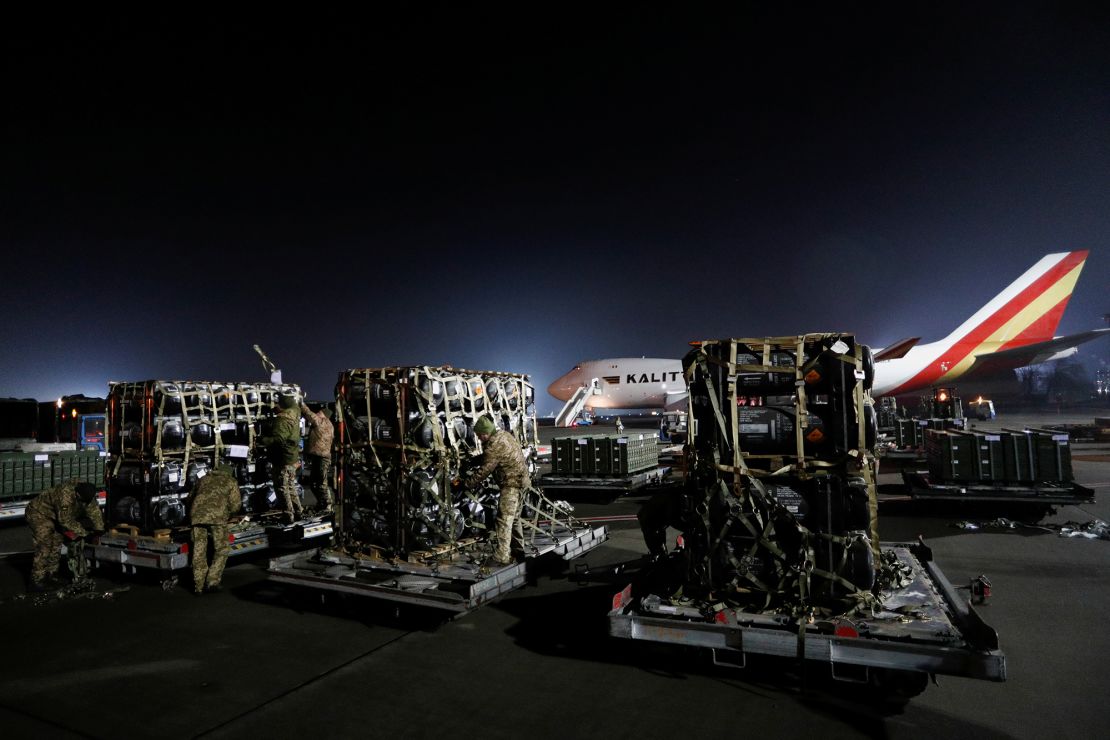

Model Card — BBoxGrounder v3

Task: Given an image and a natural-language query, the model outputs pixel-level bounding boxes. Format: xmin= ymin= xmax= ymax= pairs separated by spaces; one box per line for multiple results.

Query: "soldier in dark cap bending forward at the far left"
xmin=26 ymin=480 xmax=104 ymax=591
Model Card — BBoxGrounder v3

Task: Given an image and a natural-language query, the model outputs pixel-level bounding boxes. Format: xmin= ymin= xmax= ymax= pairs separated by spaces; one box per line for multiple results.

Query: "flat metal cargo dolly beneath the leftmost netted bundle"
xmin=85 ymin=516 xmax=333 ymax=584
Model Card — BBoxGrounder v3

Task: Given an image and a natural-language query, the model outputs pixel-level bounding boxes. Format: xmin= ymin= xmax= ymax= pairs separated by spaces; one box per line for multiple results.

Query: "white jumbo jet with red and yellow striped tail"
xmin=547 ymin=250 xmax=1110 ymax=416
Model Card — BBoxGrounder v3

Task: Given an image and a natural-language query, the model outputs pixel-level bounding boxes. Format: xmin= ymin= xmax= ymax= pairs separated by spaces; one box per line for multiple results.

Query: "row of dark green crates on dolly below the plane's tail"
xmin=925 ymin=429 xmax=1073 ymax=484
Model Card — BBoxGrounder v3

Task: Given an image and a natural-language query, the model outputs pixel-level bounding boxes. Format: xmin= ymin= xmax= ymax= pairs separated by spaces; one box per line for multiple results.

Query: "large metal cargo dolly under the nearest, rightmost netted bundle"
xmin=609 ymin=543 xmax=1006 ymax=692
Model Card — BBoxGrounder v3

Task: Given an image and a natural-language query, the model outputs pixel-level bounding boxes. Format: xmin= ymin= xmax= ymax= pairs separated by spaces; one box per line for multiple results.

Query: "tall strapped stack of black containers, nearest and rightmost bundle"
xmin=679 ymin=334 xmax=878 ymax=609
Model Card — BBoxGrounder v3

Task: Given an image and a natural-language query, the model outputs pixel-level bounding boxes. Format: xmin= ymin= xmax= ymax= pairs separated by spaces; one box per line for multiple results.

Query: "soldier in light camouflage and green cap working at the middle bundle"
xmin=466 ymin=416 xmax=531 ymax=566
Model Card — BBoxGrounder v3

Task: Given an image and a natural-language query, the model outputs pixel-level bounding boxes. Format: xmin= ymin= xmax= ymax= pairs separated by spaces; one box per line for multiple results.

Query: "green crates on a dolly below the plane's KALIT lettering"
xmin=552 ymin=434 xmax=659 ymax=476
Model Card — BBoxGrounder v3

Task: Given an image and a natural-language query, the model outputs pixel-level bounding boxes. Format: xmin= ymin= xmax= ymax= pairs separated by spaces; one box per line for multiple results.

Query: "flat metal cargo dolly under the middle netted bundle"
xmin=269 ymin=523 xmax=608 ymax=615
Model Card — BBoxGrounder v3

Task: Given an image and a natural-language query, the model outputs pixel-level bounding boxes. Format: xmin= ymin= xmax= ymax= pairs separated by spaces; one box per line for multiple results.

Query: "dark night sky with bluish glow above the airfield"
xmin=0 ymin=3 xmax=1110 ymax=413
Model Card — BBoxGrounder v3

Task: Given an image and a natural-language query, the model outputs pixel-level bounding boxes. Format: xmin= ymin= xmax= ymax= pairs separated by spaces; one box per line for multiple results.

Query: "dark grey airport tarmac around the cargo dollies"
xmin=0 ymin=415 xmax=1110 ymax=740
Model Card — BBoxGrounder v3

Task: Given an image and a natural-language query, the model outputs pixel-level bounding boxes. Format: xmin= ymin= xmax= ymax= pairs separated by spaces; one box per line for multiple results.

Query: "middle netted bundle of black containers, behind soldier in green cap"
xmin=335 ymin=366 xmax=581 ymax=559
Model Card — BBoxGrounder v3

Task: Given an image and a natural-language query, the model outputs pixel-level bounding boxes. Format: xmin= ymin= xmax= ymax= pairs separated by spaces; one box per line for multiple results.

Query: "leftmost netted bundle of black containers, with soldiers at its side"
xmin=108 ymin=381 xmax=304 ymax=533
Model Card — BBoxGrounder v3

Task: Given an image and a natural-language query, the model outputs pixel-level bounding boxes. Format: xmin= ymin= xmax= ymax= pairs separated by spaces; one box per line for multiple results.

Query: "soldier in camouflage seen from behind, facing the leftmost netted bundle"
xmin=189 ymin=465 xmax=242 ymax=594
